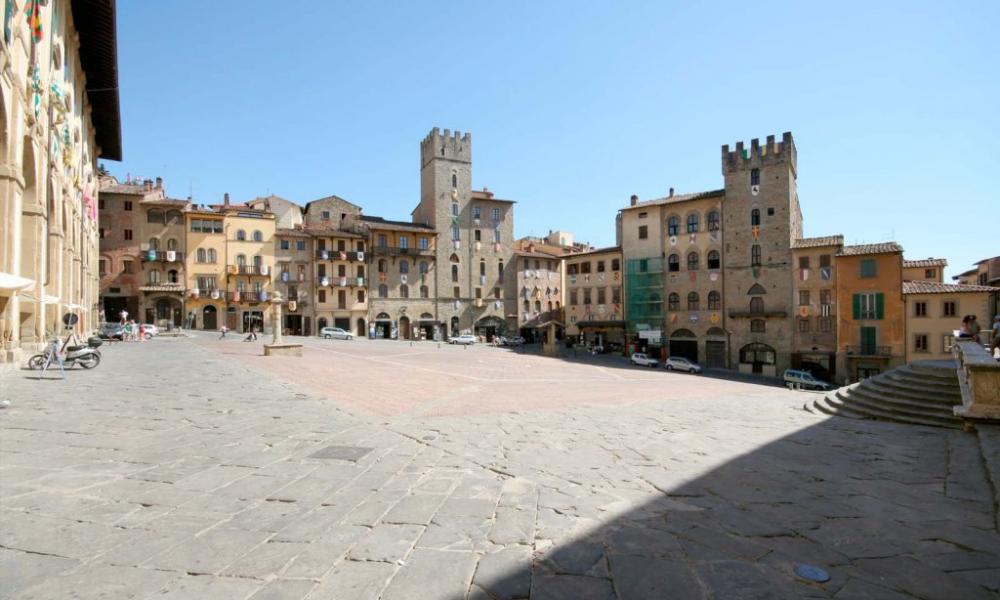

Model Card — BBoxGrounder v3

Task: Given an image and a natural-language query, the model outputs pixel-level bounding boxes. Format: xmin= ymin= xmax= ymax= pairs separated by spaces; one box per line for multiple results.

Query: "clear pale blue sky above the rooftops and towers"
xmin=106 ymin=0 xmax=1000 ymax=275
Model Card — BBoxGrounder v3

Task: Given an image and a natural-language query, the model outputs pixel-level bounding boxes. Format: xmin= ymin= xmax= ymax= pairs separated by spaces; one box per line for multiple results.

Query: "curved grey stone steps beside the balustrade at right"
xmin=805 ymin=361 xmax=963 ymax=429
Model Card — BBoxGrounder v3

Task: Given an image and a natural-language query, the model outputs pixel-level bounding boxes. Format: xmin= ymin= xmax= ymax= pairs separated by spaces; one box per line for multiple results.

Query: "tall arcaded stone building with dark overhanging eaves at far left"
xmin=0 ymin=0 xmax=121 ymax=364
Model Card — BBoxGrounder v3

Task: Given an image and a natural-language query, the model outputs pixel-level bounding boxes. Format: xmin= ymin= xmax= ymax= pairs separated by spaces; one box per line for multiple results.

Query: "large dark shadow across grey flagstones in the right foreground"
xmin=460 ymin=418 xmax=1000 ymax=600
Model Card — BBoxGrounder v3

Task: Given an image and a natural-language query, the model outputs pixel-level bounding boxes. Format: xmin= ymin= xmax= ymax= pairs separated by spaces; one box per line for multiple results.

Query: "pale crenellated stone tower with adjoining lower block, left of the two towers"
xmin=413 ymin=127 xmax=514 ymax=336
